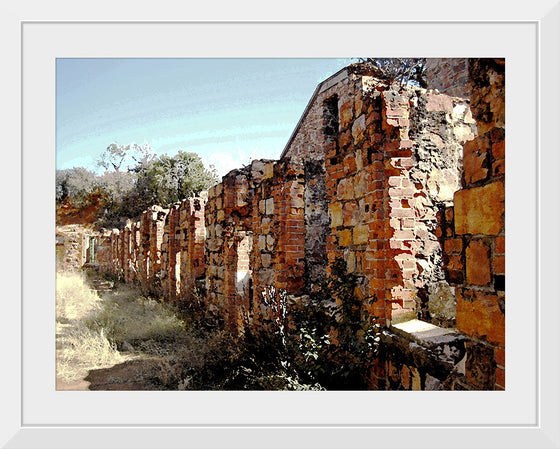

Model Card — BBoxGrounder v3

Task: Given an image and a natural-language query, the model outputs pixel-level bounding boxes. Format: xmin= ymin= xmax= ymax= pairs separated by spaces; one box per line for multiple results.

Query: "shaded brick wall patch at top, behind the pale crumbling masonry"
xmin=426 ymin=58 xmax=470 ymax=98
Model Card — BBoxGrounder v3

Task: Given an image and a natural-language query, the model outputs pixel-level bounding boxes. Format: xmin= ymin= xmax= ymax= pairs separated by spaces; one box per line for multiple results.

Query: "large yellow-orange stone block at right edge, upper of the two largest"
xmin=455 ymin=181 xmax=505 ymax=235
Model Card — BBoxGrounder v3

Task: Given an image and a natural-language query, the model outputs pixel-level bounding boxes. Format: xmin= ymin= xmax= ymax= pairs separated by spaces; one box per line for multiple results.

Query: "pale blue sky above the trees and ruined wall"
xmin=56 ymin=58 xmax=352 ymax=176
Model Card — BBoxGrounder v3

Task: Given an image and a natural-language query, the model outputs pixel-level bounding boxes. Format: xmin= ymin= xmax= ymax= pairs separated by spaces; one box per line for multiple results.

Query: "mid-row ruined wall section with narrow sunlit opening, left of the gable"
xmin=205 ymin=160 xmax=305 ymax=329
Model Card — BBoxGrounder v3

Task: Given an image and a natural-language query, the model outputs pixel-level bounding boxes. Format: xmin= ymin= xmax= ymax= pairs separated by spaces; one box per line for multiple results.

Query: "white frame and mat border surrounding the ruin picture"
xmin=5 ymin=0 xmax=560 ymax=449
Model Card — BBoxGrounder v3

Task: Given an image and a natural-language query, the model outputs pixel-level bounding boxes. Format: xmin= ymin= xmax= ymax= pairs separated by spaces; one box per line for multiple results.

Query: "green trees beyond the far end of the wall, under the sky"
xmin=56 ymin=143 xmax=218 ymax=228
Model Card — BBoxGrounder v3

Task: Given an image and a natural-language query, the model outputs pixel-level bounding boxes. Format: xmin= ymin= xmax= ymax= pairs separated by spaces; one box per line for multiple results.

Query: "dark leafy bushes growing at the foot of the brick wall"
xmin=238 ymin=259 xmax=381 ymax=390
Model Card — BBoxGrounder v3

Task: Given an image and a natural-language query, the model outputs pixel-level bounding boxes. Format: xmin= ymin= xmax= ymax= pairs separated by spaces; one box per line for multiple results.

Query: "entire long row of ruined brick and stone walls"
xmin=64 ymin=59 xmax=505 ymax=390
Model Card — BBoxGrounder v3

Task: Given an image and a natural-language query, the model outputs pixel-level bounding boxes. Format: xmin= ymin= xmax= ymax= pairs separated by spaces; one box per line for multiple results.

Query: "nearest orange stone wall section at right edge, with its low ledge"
xmin=379 ymin=59 xmax=506 ymax=390
